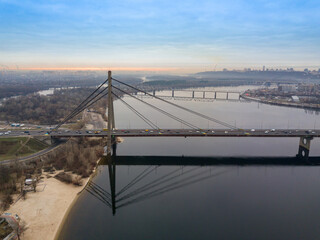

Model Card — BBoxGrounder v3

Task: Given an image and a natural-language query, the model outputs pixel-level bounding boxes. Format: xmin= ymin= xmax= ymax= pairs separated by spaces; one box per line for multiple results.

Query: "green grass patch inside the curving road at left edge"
xmin=0 ymin=137 xmax=48 ymax=161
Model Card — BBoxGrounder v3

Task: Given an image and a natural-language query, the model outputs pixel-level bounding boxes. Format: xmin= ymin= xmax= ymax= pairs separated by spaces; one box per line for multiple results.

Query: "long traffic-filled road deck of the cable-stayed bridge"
xmin=0 ymin=129 xmax=320 ymax=138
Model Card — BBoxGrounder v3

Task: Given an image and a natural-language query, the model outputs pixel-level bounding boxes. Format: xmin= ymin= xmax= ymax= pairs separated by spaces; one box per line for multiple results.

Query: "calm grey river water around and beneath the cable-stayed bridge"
xmin=59 ymin=86 xmax=320 ymax=240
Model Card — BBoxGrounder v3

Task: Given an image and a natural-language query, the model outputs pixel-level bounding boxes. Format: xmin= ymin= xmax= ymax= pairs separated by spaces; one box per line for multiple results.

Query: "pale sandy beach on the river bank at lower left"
xmin=6 ymin=174 xmax=88 ymax=240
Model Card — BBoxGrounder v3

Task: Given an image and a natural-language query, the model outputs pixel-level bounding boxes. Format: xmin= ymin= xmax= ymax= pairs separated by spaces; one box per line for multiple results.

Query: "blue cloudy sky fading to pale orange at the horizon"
xmin=0 ymin=0 xmax=320 ymax=73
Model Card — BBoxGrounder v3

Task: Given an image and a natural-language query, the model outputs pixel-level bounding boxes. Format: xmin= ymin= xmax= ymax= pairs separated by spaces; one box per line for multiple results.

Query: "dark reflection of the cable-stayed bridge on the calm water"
xmin=85 ymin=156 xmax=320 ymax=215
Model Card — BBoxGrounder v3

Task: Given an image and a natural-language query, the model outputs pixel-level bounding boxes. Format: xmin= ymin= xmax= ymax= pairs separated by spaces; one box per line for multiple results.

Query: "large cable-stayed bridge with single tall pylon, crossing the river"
xmin=0 ymin=71 xmax=320 ymax=158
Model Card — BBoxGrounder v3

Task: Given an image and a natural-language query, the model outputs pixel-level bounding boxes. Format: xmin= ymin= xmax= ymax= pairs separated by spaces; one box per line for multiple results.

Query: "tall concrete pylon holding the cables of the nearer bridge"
xmin=107 ymin=71 xmax=116 ymax=156
